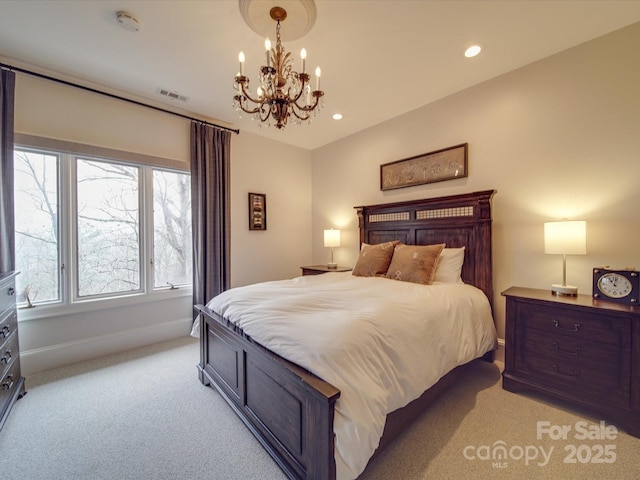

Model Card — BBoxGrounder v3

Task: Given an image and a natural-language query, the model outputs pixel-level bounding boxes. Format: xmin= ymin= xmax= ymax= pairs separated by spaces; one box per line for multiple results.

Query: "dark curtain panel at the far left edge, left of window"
xmin=0 ymin=69 xmax=16 ymax=273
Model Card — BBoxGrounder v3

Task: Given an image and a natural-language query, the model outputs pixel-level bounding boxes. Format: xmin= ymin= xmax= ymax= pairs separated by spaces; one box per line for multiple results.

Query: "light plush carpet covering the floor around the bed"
xmin=0 ymin=337 xmax=640 ymax=480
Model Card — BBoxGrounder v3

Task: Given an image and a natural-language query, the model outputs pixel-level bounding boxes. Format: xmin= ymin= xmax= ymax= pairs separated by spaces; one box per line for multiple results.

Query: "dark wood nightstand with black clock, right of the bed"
xmin=502 ymin=287 xmax=640 ymax=437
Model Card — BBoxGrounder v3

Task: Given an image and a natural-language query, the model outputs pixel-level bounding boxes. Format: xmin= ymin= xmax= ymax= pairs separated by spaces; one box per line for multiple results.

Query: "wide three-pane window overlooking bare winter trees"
xmin=14 ymin=142 xmax=192 ymax=307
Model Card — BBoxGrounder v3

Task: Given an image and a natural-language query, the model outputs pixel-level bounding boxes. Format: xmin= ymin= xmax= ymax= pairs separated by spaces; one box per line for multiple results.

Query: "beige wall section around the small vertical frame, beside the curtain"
xmin=231 ymin=132 xmax=311 ymax=287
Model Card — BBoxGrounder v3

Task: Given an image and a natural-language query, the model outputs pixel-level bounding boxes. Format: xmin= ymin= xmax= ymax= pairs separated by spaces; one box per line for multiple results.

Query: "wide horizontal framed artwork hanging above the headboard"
xmin=380 ymin=143 xmax=468 ymax=191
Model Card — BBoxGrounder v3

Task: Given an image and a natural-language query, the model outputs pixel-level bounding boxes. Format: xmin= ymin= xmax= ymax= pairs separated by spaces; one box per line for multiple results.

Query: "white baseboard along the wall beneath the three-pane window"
xmin=20 ymin=318 xmax=192 ymax=376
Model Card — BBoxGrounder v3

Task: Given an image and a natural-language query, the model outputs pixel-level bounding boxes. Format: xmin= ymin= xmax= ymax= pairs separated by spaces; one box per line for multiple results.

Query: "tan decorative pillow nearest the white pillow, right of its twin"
xmin=386 ymin=243 xmax=445 ymax=285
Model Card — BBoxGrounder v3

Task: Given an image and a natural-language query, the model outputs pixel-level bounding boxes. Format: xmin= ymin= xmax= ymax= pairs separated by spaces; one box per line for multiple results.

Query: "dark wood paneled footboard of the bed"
xmin=195 ymin=305 xmax=340 ymax=480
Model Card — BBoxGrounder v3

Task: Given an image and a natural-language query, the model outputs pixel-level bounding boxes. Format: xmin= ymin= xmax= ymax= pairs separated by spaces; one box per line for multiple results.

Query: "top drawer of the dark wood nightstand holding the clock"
xmin=519 ymin=305 xmax=631 ymax=346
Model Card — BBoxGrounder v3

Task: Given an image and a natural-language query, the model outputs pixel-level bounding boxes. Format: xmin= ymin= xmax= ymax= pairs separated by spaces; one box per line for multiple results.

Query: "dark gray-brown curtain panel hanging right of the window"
xmin=191 ymin=122 xmax=231 ymax=319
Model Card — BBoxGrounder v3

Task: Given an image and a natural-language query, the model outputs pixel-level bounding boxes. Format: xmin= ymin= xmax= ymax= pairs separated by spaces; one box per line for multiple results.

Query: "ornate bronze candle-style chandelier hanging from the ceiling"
xmin=233 ymin=7 xmax=324 ymax=129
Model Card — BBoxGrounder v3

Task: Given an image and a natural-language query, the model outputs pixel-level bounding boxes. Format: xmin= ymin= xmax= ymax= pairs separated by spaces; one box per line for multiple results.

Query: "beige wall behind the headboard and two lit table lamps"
xmin=312 ymin=20 xmax=640 ymax=338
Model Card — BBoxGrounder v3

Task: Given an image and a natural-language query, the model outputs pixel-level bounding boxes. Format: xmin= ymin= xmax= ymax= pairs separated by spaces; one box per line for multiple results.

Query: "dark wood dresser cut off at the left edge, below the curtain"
xmin=0 ymin=272 xmax=25 ymax=429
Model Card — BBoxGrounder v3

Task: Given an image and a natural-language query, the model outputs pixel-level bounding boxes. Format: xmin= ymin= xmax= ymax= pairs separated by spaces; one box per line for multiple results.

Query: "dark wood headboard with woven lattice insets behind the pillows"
xmin=355 ymin=190 xmax=496 ymax=307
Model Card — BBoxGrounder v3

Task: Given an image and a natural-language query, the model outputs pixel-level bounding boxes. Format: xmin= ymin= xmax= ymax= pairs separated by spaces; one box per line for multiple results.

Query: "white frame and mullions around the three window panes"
xmin=14 ymin=133 xmax=192 ymax=320
